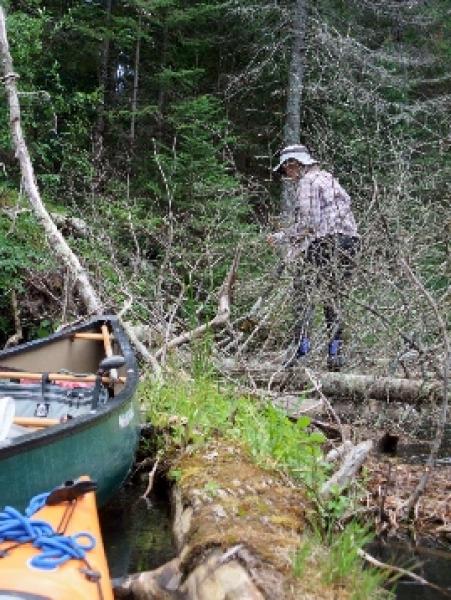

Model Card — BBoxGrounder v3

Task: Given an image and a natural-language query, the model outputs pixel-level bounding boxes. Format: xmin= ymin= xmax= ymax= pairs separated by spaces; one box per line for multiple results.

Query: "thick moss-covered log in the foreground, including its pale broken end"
xmin=115 ymin=440 xmax=349 ymax=600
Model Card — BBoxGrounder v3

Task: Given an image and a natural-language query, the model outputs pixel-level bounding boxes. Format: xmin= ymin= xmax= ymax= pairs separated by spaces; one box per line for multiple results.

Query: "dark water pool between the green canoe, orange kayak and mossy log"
xmin=99 ymin=482 xmax=175 ymax=578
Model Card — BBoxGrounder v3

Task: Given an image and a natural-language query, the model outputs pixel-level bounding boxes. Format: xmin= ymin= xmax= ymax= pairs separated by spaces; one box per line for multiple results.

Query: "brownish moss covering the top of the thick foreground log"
xmin=173 ymin=439 xmax=309 ymax=572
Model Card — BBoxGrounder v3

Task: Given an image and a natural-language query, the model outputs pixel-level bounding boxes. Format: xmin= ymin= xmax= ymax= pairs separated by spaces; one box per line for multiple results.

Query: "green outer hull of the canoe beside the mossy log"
xmin=0 ymin=317 xmax=139 ymax=510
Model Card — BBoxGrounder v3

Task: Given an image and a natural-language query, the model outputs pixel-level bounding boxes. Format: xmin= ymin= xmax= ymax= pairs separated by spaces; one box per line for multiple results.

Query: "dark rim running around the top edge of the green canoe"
xmin=0 ymin=315 xmax=139 ymax=460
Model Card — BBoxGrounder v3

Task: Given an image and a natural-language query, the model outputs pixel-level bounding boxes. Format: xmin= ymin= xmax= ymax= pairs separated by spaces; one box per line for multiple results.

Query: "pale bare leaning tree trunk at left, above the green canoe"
xmin=0 ymin=6 xmax=103 ymax=313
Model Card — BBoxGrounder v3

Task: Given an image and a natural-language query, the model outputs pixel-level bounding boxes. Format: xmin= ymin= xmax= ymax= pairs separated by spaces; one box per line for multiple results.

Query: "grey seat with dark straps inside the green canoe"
xmin=0 ymin=380 xmax=109 ymax=419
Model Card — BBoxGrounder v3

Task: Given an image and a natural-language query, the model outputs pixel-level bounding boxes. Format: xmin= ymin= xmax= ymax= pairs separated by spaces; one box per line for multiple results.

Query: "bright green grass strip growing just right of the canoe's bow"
xmin=140 ymin=375 xmax=328 ymax=489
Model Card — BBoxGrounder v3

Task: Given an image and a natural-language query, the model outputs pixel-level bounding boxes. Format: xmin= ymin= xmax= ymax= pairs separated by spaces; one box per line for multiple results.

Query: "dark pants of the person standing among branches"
xmin=294 ymin=234 xmax=360 ymax=341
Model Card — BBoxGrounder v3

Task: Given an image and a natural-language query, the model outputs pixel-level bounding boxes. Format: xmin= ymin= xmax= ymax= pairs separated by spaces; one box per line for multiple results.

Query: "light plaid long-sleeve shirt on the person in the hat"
xmin=273 ymin=167 xmax=358 ymax=251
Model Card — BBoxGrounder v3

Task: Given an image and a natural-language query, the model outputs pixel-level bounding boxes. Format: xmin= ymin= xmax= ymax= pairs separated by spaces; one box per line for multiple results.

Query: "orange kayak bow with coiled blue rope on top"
xmin=0 ymin=477 xmax=113 ymax=600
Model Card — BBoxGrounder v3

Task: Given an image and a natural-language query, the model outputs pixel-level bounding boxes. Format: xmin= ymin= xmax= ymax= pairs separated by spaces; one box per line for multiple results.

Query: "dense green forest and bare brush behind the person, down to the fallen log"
xmin=0 ymin=0 xmax=451 ymax=375
